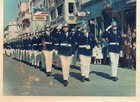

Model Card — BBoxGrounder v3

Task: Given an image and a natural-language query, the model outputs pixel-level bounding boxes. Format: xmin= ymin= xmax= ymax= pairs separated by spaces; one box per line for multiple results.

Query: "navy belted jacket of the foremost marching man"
xmin=58 ymin=32 xmax=75 ymax=56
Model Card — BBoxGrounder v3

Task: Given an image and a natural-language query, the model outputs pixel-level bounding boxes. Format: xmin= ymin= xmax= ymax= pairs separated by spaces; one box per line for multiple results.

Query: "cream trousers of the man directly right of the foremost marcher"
xmin=80 ymin=55 xmax=91 ymax=78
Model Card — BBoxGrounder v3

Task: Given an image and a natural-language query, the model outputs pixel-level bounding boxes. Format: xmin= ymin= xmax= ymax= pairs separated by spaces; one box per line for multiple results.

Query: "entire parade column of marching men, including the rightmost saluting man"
xmin=4 ymin=21 xmax=128 ymax=86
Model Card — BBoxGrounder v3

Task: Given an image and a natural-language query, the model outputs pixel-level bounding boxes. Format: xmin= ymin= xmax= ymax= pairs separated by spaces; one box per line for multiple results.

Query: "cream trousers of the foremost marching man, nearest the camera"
xmin=60 ymin=55 xmax=72 ymax=80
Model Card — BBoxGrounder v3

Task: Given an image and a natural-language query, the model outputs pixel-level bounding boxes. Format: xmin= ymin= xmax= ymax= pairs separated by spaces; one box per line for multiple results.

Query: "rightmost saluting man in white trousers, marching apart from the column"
xmin=103 ymin=21 xmax=122 ymax=81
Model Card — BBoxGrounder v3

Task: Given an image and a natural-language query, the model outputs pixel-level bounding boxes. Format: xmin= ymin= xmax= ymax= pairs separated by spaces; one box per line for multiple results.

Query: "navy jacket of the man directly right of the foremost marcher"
xmin=78 ymin=33 xmax=96 ymax=56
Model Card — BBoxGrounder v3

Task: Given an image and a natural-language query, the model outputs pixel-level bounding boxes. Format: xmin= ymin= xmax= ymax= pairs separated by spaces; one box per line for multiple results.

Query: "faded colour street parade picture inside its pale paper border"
xmin=3 ymin=0 xmax=137 ymax=97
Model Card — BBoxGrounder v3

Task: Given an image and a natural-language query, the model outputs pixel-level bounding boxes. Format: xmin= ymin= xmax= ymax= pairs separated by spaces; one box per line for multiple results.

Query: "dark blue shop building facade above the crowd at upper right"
xmin=81 ymin=0 xmax=136 ymax=35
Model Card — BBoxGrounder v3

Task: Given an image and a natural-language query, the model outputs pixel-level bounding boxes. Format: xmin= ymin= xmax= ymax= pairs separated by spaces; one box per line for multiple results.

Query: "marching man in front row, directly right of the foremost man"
xmin=78 ymin=25 xmax=96 ymax=82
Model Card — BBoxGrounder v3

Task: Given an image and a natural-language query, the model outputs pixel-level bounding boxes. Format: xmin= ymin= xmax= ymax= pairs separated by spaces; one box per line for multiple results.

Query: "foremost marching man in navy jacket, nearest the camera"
xmin=58 ymin=23 xmax=74 ymax=86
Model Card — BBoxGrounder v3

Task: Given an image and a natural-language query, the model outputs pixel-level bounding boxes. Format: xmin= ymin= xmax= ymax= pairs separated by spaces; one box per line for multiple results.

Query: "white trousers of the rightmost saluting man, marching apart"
xmin=109 ymin=52 xmax=119 ymax=77
